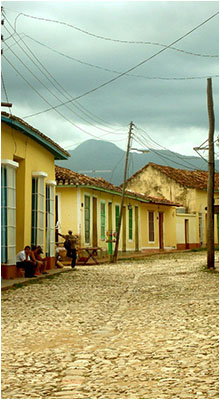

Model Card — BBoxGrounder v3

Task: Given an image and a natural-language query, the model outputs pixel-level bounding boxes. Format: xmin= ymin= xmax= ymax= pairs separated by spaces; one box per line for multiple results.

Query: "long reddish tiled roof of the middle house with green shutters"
xmin=55 ymin=166 xmax=181 ymax=206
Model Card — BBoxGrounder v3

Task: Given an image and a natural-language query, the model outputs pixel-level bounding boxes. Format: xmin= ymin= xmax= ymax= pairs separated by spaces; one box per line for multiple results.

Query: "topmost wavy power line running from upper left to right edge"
xmin=14 ymin=13 xmax=218 ymax=58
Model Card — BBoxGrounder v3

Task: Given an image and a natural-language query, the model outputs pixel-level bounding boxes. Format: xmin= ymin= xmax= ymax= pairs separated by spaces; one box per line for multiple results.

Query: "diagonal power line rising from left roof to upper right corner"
xmin=19 ymin=12 xmax=218 ymax=118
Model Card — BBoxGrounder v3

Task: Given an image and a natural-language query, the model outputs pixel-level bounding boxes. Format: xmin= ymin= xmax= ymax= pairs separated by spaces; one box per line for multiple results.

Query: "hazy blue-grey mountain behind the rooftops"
xmin=56 ymin=139 xmax=218 ymax=185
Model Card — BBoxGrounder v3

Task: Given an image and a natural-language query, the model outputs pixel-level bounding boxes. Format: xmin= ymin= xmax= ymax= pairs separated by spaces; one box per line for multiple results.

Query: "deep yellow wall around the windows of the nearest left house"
xmin=1 ymin=122 xmax=55 ymax=252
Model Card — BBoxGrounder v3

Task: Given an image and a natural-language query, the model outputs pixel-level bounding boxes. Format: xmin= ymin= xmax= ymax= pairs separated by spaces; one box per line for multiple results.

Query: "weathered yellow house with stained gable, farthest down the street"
xmin=124 ymin=163 xmax=219 ymax=249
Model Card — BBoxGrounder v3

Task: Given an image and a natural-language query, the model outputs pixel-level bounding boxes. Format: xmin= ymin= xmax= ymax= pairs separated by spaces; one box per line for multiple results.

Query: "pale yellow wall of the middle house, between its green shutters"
xmin=56 ymin=186 xmax=176 ymax=251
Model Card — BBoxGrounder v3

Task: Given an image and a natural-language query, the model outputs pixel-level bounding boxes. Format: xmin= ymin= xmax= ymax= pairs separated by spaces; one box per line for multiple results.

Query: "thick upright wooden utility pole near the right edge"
xmin=207 ymin=78 xmax=215 ymax=269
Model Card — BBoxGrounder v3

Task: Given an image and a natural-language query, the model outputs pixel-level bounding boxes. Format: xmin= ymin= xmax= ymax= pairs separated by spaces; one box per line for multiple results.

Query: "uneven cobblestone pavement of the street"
xmin=2 ymin=252 xmax=219 ymax=399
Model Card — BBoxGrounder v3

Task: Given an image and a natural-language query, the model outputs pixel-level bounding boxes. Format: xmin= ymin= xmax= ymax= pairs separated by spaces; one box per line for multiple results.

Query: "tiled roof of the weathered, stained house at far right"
xmin=124 ymin=163 xmax=219 ymax=190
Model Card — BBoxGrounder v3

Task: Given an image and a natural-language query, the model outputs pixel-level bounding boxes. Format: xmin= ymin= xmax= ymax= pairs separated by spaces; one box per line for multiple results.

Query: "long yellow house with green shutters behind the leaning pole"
xmin=56 ymin=166 xmax=179 ymax=252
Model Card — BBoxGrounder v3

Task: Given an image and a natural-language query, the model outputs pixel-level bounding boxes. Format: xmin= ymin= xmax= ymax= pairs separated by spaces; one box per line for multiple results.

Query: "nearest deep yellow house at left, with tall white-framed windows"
xmin=1 ymin=112 xmax=69 ymax=277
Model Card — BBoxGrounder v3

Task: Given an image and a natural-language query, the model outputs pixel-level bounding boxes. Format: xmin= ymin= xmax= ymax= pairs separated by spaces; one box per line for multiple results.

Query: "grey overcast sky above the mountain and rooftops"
xmin=2 ymin=0 xmax=219 ymax=155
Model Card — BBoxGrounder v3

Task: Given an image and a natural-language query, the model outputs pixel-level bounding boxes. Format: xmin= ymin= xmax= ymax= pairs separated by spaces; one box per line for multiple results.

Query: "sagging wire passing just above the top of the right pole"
xmin=24 ymin=35 xmax=219 ymax=81
